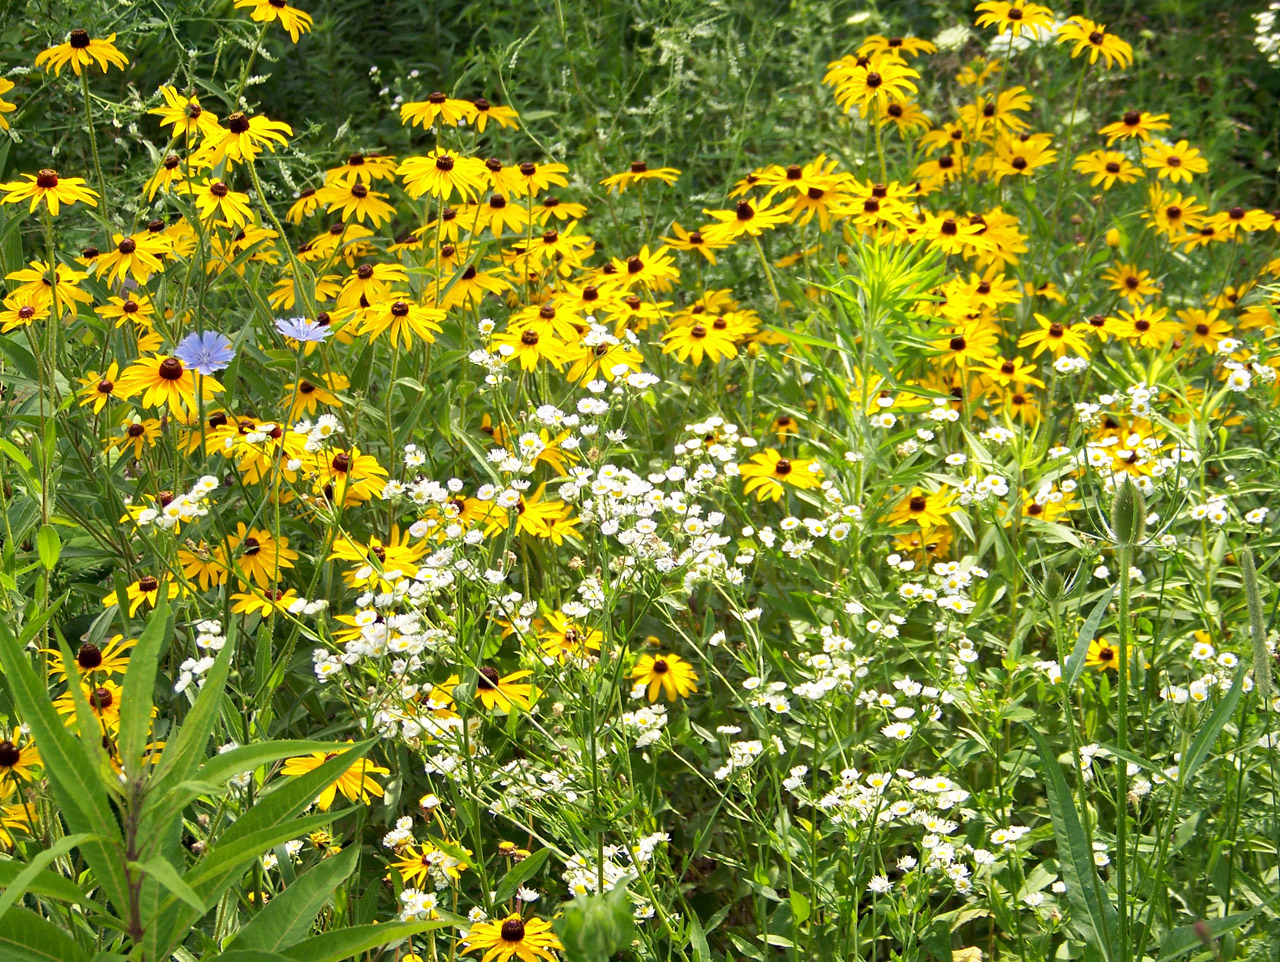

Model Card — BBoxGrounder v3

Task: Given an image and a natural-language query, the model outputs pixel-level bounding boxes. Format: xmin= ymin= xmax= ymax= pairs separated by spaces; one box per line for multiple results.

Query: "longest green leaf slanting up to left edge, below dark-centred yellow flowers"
xmin=0 ymin=608 xmax=128 ymax=906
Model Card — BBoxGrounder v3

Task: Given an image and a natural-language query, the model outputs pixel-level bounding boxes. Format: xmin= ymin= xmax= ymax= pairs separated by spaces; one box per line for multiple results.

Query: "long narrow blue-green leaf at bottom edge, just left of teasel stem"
xmin=1027 ymin=725 xmax=1120 ymax=959
